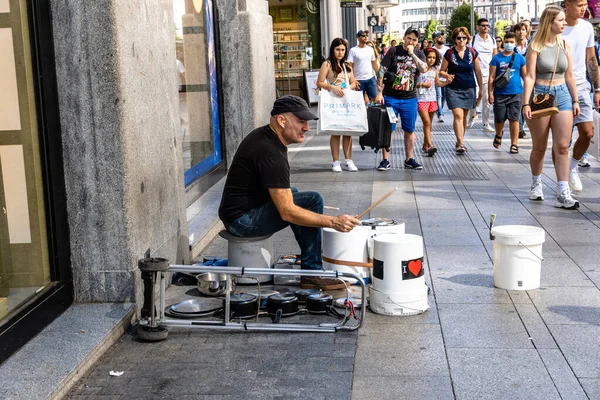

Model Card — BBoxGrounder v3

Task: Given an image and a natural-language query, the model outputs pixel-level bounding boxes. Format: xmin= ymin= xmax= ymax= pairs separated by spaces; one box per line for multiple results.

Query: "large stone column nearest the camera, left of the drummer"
xmin=52 ymin=0 xmax=189 ymax=304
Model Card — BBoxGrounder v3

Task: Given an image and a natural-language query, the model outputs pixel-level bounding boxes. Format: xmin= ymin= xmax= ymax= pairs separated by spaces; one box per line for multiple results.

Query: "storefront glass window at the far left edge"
xmin=0 ymin=0 xmax=51 ymax=324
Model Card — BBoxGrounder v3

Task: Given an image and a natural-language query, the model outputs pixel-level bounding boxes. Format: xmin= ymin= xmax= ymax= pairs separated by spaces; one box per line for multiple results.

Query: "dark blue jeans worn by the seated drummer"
xmin=226 ymin=187 xmax=324 ymax=270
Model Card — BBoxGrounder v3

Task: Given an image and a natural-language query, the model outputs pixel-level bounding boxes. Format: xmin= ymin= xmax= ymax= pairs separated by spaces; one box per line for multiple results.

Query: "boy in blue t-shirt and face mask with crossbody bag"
xmin=488 ymin=32 xmax=527 ymax=154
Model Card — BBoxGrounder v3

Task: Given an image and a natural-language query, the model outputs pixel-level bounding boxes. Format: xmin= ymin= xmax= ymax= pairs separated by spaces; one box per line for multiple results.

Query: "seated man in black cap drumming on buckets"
xmin=219 ymin=96 xmax=360 ymax=290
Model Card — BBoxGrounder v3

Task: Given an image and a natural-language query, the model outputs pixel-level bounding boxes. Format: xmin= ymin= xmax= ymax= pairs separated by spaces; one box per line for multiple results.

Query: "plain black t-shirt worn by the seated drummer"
xmin=219 ymin=125 xmax=290 ymax=225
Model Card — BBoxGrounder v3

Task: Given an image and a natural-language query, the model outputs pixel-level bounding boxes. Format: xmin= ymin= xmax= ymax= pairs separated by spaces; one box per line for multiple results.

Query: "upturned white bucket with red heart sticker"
xmin=369 ymin=234 xmax=429 ymax=315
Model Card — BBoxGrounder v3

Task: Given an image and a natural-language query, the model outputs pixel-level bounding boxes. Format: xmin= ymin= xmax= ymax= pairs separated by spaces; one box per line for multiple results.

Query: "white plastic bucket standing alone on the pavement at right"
xmin=492 ymin=225 xmax=546 ymax=290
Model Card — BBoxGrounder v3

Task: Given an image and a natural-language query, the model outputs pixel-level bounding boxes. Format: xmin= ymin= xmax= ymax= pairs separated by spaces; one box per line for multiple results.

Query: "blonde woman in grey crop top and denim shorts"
xmin=522 ymin=6 xmax=579 ymax=210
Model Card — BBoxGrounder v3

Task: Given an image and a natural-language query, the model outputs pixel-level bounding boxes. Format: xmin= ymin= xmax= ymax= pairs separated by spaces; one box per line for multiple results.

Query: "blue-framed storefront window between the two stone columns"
xmin=173 ymin=0 xmax=222 ymax=185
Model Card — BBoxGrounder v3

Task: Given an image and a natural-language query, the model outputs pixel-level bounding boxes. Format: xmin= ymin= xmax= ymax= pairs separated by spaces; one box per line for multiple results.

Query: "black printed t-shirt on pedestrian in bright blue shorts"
xmin=381 ymin=45 xmax=425 ymax=99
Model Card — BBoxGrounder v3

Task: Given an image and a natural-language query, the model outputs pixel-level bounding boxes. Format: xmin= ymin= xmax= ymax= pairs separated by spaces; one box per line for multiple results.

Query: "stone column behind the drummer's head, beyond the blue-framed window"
xmin=215 ymin=0 xmax=275 ymax=164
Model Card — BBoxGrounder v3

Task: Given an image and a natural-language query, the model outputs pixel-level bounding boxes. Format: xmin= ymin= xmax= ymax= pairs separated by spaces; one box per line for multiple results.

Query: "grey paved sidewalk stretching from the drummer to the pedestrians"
xmin=69 ymin=118 xmax=600 ymax=400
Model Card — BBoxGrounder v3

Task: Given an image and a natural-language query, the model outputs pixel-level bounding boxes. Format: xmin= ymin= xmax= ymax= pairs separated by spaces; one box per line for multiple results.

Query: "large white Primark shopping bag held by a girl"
xmin=317 ymin=67 xmax=369 ymax=136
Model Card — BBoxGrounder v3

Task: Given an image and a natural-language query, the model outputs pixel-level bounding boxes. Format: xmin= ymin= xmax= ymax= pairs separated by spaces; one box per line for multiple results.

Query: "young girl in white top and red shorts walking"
xmin=417 ymin=47 xmax=448 ymax=157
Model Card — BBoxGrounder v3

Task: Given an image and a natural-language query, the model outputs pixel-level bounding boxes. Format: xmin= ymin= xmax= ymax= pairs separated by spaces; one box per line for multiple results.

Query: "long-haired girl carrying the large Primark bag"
xmin=317 ymin=38 xmax=358 ymax=172
